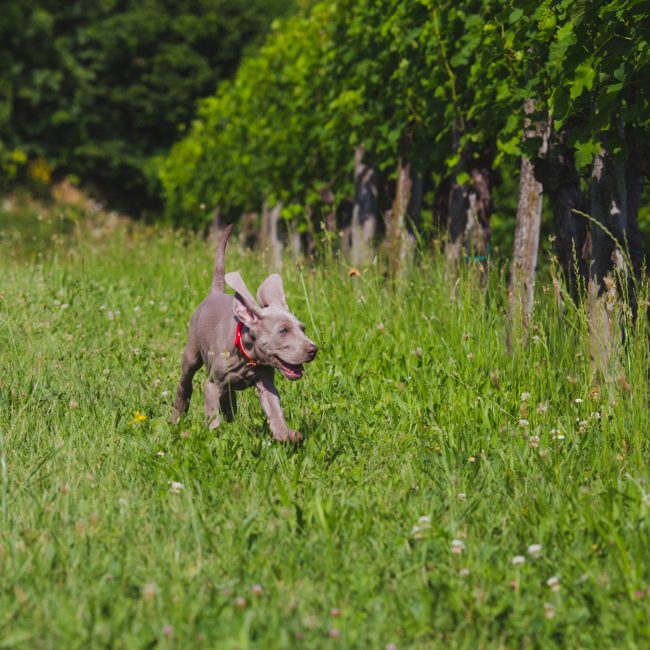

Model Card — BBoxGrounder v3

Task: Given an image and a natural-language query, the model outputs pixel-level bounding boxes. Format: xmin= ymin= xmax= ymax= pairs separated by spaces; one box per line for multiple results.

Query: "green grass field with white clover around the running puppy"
xmin=0 ymin=210 xmax=650 ymax=649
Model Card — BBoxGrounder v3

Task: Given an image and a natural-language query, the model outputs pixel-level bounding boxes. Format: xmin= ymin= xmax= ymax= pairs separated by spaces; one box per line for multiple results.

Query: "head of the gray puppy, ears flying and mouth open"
xmin=225 ymin=273 xmax=318 ymax=381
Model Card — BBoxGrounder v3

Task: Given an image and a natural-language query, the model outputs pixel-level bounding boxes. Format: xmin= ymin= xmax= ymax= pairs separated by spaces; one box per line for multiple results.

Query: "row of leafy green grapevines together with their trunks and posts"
xmin=161 ymin=0 xmax=650 ymax=292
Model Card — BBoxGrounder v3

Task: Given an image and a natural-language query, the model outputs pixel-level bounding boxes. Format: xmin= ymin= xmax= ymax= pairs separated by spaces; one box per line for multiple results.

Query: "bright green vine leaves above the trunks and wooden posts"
xmin=161 ymin=0 xmax=650 ymax=232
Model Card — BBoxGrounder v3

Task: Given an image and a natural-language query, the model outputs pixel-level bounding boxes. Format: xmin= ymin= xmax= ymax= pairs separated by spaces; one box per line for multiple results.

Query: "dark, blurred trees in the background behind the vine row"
xmin=0 ymin=0 xmax=292 ymax=207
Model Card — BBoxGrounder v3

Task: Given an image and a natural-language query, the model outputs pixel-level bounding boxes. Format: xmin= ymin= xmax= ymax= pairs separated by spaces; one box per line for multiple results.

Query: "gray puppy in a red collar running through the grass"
xmin=171 ymin=226 xmax=318 ymax=442
